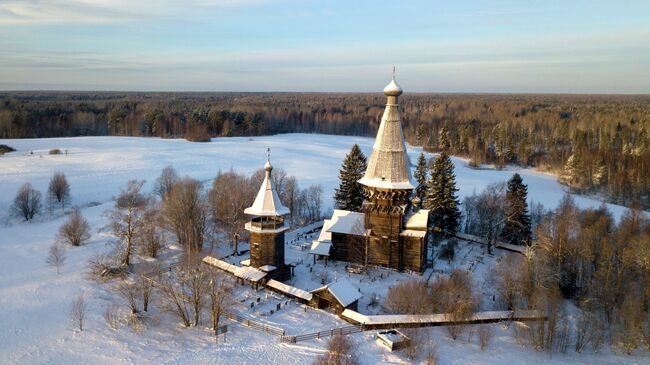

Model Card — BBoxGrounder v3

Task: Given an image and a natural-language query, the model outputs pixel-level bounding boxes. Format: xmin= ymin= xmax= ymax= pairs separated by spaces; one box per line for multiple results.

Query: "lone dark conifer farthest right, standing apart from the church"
xmin=501 ymin=174 xmax=531 ymax=245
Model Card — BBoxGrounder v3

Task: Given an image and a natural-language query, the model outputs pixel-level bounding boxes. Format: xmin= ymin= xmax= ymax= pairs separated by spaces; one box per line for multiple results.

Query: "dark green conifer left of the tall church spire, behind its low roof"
xmin=334 ymin=144 xmax=367 ymax=212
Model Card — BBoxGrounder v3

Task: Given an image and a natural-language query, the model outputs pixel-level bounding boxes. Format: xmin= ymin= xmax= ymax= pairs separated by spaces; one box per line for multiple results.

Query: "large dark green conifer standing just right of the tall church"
xmin=424 ymin=152 xmax=460 ymax=234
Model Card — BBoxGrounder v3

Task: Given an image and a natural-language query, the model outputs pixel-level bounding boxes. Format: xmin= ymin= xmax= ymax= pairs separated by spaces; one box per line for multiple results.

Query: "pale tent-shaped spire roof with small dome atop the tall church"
xmin=359 ymin=79 xmax=414 ymax=189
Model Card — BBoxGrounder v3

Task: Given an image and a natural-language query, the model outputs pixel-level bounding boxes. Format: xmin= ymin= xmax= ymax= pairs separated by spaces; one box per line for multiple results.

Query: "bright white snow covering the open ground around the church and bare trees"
xmin=0 ymin=134 xmax=650 ymax=365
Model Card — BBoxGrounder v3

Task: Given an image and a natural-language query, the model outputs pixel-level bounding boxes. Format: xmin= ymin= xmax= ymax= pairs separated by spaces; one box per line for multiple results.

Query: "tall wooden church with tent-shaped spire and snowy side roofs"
xmin=311 ymin=76 xmax=429 ymax=273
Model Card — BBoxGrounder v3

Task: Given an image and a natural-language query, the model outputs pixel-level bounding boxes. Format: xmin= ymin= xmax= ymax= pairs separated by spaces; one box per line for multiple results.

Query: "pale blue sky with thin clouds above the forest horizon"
xmin=0 ymin=0 xmax=650 ymax=93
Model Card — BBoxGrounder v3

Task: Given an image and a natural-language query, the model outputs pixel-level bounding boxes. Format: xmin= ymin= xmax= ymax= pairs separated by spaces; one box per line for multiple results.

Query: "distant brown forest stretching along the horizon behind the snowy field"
xmin=0 ymin=92 xmax=650 ymax=209
